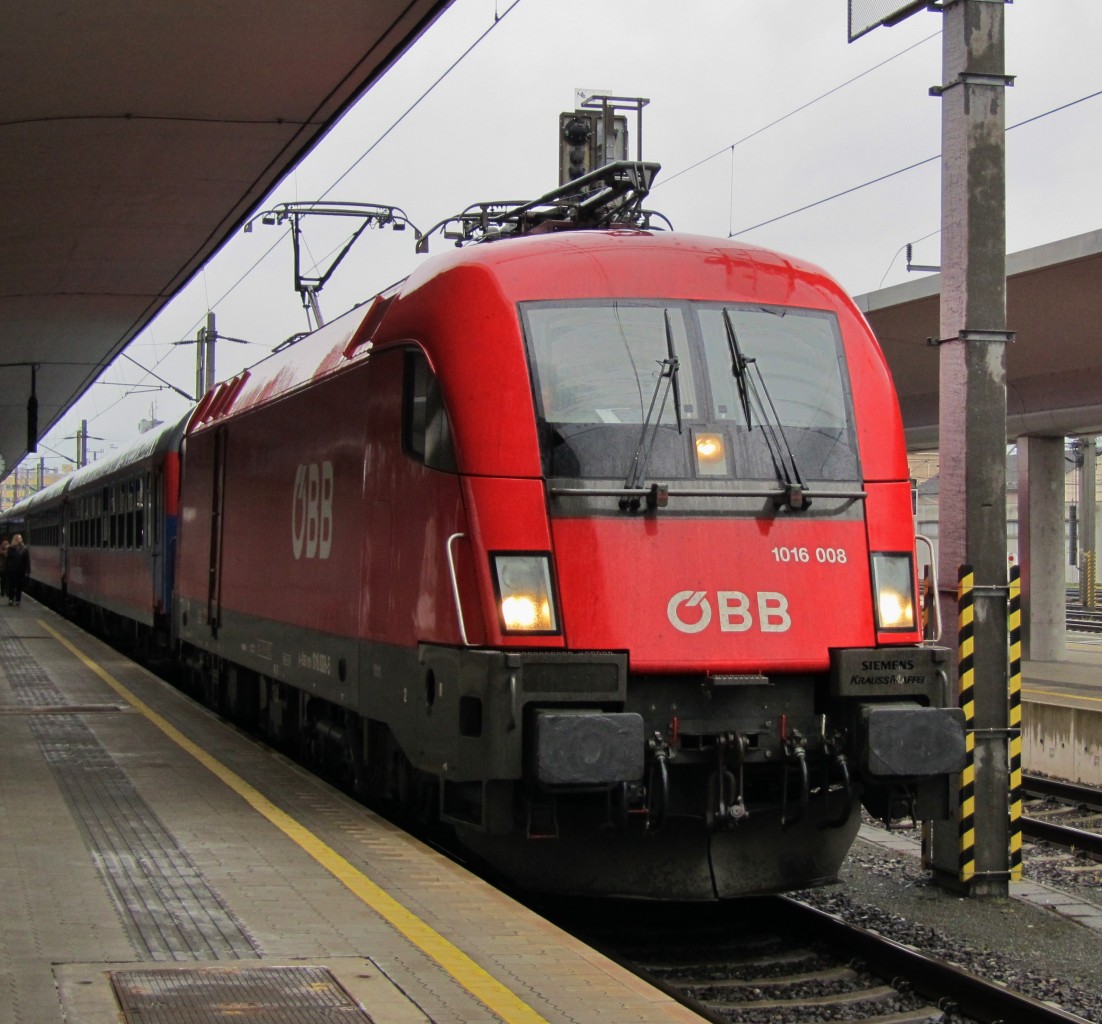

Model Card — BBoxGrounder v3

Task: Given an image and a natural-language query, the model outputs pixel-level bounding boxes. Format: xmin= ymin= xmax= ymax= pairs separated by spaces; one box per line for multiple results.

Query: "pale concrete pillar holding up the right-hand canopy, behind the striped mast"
xmin=1018 ymin=438 xmax=1068 ymax=661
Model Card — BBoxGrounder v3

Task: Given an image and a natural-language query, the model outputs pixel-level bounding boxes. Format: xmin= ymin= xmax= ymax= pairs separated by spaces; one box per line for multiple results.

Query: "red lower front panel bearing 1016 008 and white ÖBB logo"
xmin=554 ymin=519 xmax=875 ymax=673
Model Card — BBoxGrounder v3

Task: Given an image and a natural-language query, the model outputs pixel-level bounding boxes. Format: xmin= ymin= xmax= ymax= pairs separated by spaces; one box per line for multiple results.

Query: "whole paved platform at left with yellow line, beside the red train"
xmin=0 ymin=599 xmax=699 ymax=1024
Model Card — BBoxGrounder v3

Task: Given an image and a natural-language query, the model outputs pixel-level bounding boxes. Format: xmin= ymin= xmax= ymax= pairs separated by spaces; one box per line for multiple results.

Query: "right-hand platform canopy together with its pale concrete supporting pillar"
xmin=857 ymin=230 xmax=1102 ymax=661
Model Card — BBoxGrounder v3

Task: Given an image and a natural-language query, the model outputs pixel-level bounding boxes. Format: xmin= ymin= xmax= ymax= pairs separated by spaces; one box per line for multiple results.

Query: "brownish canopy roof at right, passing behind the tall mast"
xmin=857 ymin=230 xmax=1102 ymax=451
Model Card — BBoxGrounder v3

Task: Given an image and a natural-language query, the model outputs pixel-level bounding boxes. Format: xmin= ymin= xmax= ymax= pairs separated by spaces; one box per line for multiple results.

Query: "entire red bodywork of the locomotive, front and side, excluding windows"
xmin=179 ymin=231 xmax=919 ymax=671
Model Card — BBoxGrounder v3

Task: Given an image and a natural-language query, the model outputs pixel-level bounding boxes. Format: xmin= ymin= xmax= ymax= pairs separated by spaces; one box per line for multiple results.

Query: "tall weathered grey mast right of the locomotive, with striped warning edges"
xmin=930 ymin=0 xmax=1012 ymax=895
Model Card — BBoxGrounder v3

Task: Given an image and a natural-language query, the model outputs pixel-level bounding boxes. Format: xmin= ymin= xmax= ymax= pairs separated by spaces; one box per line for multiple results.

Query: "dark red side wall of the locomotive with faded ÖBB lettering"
xmin=177 ymin=349 xmax=463 ymax=646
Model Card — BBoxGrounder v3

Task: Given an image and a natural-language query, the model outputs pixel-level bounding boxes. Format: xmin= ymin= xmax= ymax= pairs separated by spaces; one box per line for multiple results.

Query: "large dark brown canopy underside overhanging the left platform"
xmin=0 ymin=0 xmax=452 ymax=476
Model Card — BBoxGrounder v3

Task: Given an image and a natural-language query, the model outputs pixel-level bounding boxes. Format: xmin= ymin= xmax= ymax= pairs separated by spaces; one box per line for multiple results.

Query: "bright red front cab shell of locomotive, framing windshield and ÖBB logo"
xmin=376 ymin=231 xmax=919 ymax=671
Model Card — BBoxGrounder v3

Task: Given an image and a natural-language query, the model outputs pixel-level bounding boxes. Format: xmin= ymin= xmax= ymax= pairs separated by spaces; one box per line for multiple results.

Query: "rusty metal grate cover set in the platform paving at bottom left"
xmin=111 ymin=967 xmax=371 ymax=1024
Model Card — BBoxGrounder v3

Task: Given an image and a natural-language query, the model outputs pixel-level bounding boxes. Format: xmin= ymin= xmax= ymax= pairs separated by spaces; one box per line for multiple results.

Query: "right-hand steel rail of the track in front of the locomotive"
xmin=779 ymin=896 xmax=1088 ymax=1024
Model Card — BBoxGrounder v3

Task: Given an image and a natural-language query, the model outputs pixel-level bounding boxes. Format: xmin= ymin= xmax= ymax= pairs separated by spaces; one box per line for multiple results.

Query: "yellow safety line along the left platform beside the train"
xmin=37 ymin=619 xmax=548 ymax=1024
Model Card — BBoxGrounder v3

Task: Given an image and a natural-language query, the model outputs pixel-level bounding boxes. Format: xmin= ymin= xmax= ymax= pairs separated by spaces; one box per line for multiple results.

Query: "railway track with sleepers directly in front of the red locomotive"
xmin=537 ymin=896 xmax=1084 ymax=1024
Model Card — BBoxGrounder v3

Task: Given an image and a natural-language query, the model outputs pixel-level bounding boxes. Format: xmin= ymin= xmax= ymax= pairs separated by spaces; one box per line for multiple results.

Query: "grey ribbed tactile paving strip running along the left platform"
xmin=0 ymin=630 xmax=260 ymax=960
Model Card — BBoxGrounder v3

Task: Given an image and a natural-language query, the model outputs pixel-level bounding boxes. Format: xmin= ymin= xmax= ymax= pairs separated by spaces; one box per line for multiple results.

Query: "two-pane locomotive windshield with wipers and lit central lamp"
xmin=521 ymin=301 xmax=860 ymax=483
